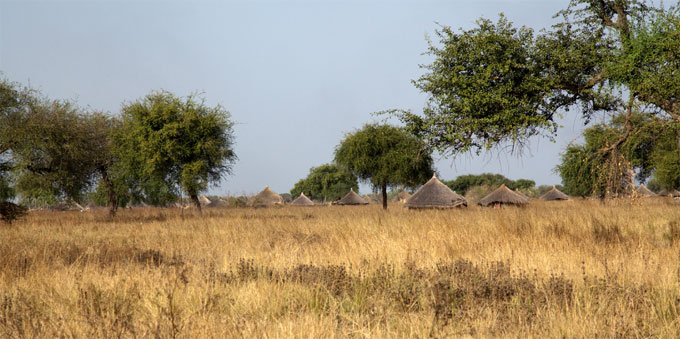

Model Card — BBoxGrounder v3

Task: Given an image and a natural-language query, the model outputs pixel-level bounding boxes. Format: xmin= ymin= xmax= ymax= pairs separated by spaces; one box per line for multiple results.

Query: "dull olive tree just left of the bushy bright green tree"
xmin=11 ymin=98 xmax=106 ymax=203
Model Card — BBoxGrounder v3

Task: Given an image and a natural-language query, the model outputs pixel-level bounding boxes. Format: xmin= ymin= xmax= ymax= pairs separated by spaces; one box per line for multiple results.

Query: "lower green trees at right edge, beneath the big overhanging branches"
xmin=557 ymin=114 xmax=680 ymax=196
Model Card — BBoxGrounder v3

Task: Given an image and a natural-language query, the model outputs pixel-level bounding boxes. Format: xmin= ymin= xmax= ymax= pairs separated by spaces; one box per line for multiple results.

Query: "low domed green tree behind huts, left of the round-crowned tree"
xmin=290 ymin=164 xmax=359 ymax=201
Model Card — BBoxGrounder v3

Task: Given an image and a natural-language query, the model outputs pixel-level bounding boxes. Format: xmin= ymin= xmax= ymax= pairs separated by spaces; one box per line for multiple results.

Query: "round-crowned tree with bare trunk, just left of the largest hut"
xmin=335 ymin=124 xmax=434 ymax=209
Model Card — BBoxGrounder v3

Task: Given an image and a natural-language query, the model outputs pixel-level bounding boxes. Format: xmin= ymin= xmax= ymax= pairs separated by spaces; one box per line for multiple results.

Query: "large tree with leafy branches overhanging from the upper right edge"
xmin=393 ymin=0 xmax=680 ymax=197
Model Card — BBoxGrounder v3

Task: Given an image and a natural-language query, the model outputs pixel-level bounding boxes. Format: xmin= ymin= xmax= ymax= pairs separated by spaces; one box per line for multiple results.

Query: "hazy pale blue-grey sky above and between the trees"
xmin=0 ymin=0 xmax=583 ymax=195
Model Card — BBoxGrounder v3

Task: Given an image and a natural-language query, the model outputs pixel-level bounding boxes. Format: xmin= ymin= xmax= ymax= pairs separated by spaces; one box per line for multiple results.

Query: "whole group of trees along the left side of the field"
xmin=0 ymin=79 xmax=236 ymax=215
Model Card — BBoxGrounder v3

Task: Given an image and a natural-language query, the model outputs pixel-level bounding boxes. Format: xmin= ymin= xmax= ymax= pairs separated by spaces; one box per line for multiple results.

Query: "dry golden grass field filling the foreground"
xmin=0 ymin=199 xmax=680 ymax=338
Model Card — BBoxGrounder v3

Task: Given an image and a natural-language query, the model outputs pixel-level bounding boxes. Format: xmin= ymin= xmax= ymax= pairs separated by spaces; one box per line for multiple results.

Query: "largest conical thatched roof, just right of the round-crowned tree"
xmin=404 ymin=175 xmax=467 ymax=209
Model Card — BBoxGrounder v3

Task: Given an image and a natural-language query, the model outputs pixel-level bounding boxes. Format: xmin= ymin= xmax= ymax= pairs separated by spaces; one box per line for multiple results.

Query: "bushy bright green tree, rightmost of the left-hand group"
xmin=114 ymin=91 xmax=236 ymax=211
